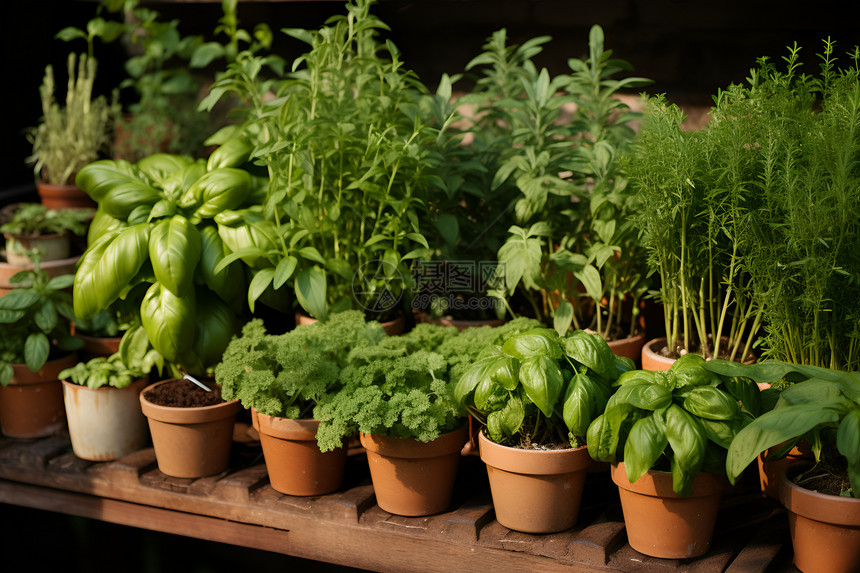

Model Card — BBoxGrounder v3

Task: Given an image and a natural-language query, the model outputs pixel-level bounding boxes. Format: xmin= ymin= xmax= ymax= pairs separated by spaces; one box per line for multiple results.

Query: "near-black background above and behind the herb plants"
xmin=0 ymin=0 xmax=860 ymax=198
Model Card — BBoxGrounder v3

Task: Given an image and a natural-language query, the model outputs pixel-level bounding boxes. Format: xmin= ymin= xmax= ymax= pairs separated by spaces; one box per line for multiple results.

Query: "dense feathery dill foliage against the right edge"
xmin=735 ymin=39 xmax=860 ymax=370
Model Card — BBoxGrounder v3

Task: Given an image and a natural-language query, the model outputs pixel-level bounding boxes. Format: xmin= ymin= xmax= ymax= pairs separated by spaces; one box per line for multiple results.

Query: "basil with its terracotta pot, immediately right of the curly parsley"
xmin=455 ymin=329 xmax=634 ymax=533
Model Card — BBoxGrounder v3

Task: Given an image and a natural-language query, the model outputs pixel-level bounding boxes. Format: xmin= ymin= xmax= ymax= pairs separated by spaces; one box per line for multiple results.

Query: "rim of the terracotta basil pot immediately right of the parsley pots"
xmin=478 ymin=430 xmax=592 ymax=475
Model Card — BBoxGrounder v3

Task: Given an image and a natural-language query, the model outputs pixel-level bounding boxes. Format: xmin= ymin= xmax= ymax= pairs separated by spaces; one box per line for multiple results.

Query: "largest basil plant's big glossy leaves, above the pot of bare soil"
xmin=73 ymin=146 xmax=256 ymax=374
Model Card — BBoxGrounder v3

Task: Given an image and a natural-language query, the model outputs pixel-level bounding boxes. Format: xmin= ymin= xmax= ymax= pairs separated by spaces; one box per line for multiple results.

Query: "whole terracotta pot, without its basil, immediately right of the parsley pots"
xmin=478 ymin=432 xmax=592 ymax=533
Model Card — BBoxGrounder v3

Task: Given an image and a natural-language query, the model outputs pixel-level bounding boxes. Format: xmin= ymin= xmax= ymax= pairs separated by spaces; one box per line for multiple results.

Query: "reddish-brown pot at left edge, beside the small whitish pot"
xmin=0 ymin=353 xmax=78 ymax=438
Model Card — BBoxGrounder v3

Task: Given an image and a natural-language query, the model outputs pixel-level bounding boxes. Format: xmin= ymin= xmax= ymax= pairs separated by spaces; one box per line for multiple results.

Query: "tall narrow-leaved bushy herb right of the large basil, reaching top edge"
xmin=201 ymin=0 xmax=432 ymax=319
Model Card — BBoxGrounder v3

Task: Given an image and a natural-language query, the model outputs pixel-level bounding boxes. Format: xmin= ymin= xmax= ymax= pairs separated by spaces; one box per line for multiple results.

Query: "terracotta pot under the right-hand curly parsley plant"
xmin=359 ymin=425 xmax=469 ymax=516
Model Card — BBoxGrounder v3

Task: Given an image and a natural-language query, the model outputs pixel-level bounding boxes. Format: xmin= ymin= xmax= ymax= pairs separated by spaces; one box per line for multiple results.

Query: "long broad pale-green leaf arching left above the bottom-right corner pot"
xmin=726 ymin=397 xmax=843 ymax=483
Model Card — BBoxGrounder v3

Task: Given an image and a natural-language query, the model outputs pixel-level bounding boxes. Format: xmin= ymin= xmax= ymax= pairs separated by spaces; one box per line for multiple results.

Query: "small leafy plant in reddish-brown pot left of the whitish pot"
xmin=0 ymin=257 xmax=81 ymax=438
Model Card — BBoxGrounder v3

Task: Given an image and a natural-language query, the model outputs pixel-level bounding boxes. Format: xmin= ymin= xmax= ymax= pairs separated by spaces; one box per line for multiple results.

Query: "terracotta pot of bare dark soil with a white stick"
xmin=140 ymin=378 xmax=241 ymax=478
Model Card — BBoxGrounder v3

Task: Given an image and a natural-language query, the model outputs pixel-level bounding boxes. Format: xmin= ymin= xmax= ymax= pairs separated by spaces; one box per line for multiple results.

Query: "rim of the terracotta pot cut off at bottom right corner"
xmin=779 ymin=463 xmax=860 ymax=527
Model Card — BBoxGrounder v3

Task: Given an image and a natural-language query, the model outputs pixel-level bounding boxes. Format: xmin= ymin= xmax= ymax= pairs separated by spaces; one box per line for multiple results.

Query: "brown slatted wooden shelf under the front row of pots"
xmin=0 ymin=425 xmax=796 ymax=573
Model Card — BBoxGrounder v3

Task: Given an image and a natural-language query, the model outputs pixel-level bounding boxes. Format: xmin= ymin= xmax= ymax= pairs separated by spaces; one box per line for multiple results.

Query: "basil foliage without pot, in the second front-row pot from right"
xmin=587 ymin=354 xmax=761 ymax=496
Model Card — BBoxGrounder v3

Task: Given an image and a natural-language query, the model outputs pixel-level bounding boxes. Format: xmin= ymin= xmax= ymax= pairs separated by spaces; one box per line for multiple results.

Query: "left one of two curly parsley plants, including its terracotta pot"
xmin=215 ymin=311 xmax=385 ymax=495
